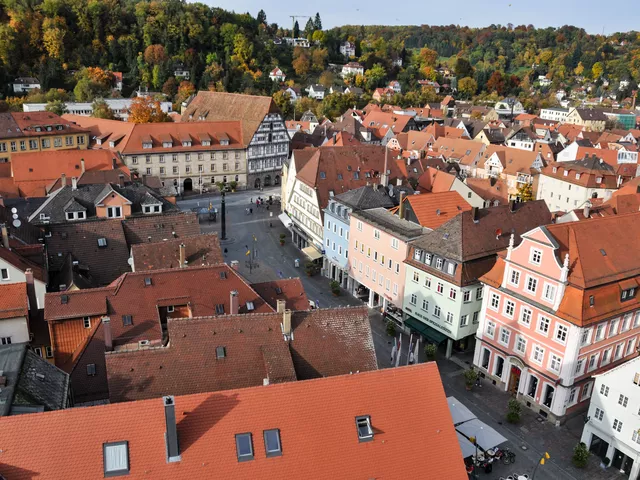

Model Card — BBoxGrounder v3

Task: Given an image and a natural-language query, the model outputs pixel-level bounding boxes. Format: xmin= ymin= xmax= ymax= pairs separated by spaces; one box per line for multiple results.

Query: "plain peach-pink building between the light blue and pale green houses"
xmin=349 ymin=208 xmax=424 ymax=313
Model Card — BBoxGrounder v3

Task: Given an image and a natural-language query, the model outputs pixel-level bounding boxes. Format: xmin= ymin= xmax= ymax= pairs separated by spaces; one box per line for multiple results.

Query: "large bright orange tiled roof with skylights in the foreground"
xmin=0 ymin=362 xmax=467 ymax=480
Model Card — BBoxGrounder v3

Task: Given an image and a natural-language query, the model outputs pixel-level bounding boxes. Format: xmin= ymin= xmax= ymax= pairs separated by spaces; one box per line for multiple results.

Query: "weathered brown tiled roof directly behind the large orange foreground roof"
xmin=106 ymin=307 xmax=377 ymax=402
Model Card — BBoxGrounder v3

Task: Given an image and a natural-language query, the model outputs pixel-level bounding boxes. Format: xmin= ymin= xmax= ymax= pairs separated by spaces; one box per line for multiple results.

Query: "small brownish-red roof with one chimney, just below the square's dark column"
xmin=131 ymin=233 xmax=224 ymax=271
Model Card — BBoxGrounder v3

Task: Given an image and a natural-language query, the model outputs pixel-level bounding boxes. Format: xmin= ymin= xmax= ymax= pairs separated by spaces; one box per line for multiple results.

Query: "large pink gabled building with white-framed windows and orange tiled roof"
xmin=474 ymin=214 xmax=640 ymax=421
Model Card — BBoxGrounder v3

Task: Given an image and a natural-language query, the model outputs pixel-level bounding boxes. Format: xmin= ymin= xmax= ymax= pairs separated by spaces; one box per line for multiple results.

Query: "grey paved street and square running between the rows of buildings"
xmin=178 ymin=187 xmax=626 ymax=480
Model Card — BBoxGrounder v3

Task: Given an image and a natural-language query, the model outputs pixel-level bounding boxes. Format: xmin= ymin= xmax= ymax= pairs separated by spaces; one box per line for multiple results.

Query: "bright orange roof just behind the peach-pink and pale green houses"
xmin=405 ymin=191 xmax=471 ymax=229
